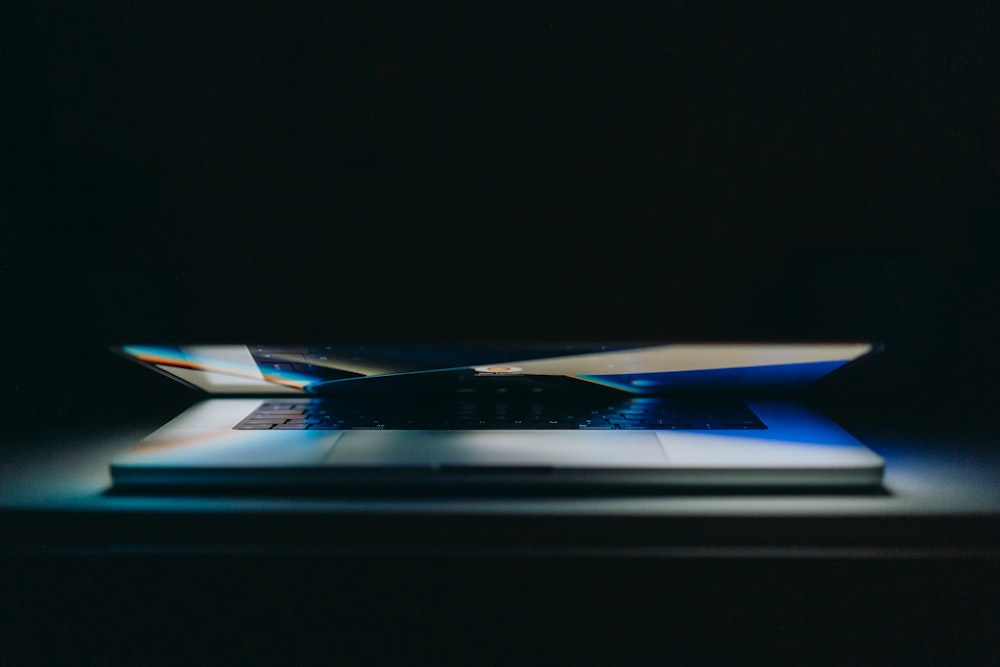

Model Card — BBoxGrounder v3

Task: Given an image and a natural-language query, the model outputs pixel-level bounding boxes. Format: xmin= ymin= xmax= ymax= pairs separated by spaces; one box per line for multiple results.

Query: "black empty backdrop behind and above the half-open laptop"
xmin=0 ymin=2 xmax=1000 ymax=418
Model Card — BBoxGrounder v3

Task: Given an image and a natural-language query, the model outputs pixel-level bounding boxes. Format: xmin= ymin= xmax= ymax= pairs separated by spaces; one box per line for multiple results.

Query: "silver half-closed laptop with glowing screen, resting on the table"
xmin=110 ymin=342 xmax=884 ymax=488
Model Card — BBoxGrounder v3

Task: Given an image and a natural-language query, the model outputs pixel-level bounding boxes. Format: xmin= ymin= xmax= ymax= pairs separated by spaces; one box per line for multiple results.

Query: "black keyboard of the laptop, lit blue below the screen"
xmin=234 ymin=397 xmax=767 ymax=430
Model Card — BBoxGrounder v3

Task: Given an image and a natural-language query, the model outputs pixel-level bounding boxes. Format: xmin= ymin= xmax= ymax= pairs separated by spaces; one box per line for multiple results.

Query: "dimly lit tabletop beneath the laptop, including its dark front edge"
xmin=0 ymin=400 xmax=1000 ymax=557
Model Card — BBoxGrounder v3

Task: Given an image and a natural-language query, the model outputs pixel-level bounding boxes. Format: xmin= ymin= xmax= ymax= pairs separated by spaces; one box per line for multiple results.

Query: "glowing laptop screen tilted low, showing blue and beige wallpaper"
xmin=115 ymin=343 xmax=874 ymax=395
